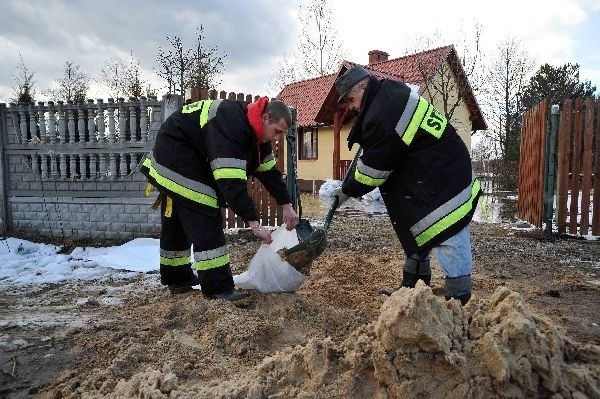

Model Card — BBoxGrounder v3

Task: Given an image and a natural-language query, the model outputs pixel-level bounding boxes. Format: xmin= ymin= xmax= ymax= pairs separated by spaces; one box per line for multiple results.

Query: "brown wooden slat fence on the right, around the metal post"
xmin=517 ymin=97 xmax=600 ymax=235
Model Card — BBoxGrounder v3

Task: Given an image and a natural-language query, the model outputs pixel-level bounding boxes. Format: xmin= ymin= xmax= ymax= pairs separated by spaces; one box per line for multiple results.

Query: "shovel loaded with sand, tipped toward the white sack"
xmin=278 ymin=147 xmax=362 ymax=274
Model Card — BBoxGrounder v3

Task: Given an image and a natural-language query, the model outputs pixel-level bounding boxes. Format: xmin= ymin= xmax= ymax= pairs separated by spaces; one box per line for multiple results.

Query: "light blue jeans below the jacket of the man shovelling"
xmin=408 ymin=226 xmax=473 ymax=278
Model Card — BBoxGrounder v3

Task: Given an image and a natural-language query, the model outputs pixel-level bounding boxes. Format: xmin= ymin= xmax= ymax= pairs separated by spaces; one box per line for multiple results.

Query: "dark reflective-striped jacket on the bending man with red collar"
xmin=141 ymin=100 xmax=290 ymax=221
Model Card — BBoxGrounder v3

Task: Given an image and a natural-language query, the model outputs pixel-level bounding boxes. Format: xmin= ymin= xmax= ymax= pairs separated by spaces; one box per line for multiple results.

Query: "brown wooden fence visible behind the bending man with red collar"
xmin=186 ymin=88 xmax=288 ymax=228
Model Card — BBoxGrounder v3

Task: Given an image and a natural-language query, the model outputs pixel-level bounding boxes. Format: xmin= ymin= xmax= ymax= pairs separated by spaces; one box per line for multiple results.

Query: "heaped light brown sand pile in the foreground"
xmin=84 ymin=284 xmax=600 ymax=399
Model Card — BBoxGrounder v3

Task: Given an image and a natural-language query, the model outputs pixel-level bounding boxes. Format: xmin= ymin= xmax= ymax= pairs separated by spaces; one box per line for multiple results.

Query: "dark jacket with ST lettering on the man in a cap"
xmin=343 ymin=78 xmax=481 ymax=254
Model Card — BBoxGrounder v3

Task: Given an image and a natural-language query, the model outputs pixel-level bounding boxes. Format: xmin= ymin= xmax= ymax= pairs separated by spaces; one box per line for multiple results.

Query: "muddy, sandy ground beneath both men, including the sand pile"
xmin=0 ymin=198 xmax=600 ymax=399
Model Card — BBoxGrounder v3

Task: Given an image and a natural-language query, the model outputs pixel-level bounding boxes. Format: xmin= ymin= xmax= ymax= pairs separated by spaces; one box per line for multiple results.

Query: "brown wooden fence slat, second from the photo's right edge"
xmin=579 ymin=97 xmax=594 ymax=235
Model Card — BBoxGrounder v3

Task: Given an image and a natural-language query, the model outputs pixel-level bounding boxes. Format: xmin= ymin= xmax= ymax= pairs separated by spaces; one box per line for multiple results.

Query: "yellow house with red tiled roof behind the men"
xmin=277 ymin=46 xmax=487 ymax=190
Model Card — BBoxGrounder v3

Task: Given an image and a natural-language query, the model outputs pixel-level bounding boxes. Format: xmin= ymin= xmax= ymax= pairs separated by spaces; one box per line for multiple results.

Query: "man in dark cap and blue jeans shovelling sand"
xmin=334 ymin=66 xmax=482 ymax=304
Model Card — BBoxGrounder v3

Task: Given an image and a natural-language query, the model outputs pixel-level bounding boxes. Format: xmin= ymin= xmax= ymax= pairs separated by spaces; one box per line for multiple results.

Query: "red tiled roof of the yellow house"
xmin=277 ymin=46 xmax=486 ymax=130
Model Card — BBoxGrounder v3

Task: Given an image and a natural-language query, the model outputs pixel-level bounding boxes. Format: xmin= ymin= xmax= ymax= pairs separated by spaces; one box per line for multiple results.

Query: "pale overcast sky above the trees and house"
xmin=0 ymin=0 xmax=600 ymax=102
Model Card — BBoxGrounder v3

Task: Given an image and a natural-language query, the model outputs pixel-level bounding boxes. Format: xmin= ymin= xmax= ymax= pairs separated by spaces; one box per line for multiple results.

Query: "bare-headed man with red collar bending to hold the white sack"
xmin=141 ymin=97 xmax=298 ymax=305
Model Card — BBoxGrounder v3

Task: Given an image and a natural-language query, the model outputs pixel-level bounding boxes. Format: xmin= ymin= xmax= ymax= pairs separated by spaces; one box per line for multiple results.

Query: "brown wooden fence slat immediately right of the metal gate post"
xmin=556 ymin=99 xmax=572 ymax=234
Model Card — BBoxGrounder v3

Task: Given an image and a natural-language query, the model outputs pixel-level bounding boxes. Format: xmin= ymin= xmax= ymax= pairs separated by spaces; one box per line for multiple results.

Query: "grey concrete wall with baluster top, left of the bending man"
xmin=0 ymin=96 xmax=181 ymax=239
